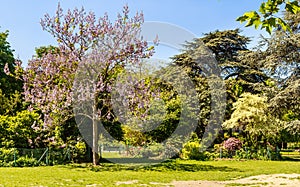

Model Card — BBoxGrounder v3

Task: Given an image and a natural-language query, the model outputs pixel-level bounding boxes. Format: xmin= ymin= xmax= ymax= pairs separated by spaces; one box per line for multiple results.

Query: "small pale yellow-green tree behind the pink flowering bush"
xmin=223 ymin=93 xmax=281 ymax=145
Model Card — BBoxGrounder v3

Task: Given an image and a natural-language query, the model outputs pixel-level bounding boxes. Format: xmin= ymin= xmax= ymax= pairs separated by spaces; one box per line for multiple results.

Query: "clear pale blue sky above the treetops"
xmin=0 ymin=0 xmax=267 ymax=66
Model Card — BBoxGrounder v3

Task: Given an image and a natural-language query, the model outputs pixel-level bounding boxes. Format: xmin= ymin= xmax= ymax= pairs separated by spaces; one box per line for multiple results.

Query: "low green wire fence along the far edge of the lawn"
xmin=0 ymin=144 xmax=300 ymax=166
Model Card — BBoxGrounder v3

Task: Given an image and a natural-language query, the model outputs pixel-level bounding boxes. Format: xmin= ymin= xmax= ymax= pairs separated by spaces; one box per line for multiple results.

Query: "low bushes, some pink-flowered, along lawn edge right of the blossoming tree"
xmin=102 ymin=138 xmax=281 ymax=160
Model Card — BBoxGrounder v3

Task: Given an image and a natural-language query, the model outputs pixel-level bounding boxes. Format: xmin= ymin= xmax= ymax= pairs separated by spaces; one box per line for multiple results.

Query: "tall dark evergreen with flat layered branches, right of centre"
xmin=172 ymin=29 xmax=268 ymax=136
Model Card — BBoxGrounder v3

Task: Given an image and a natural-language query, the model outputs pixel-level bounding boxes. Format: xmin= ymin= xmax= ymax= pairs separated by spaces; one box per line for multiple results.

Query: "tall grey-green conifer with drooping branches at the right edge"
xmin=248 ymin=8 xmax=300 ymax=142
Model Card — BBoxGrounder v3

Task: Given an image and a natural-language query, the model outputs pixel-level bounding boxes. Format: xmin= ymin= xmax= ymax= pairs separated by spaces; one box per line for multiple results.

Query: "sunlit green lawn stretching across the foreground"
xmin=0 ymin=160 xmax=300 ymax=186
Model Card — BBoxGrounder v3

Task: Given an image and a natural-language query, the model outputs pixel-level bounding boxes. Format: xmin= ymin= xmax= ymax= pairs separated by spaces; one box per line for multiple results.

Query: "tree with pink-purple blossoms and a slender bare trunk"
xmin=24 ymin=5 xmax=153 ymax=164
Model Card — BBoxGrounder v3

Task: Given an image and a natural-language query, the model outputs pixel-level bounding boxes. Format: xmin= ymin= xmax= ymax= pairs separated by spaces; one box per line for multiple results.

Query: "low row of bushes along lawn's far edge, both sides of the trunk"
xmin=0 ymin=138 xmax=280 ymax=167
